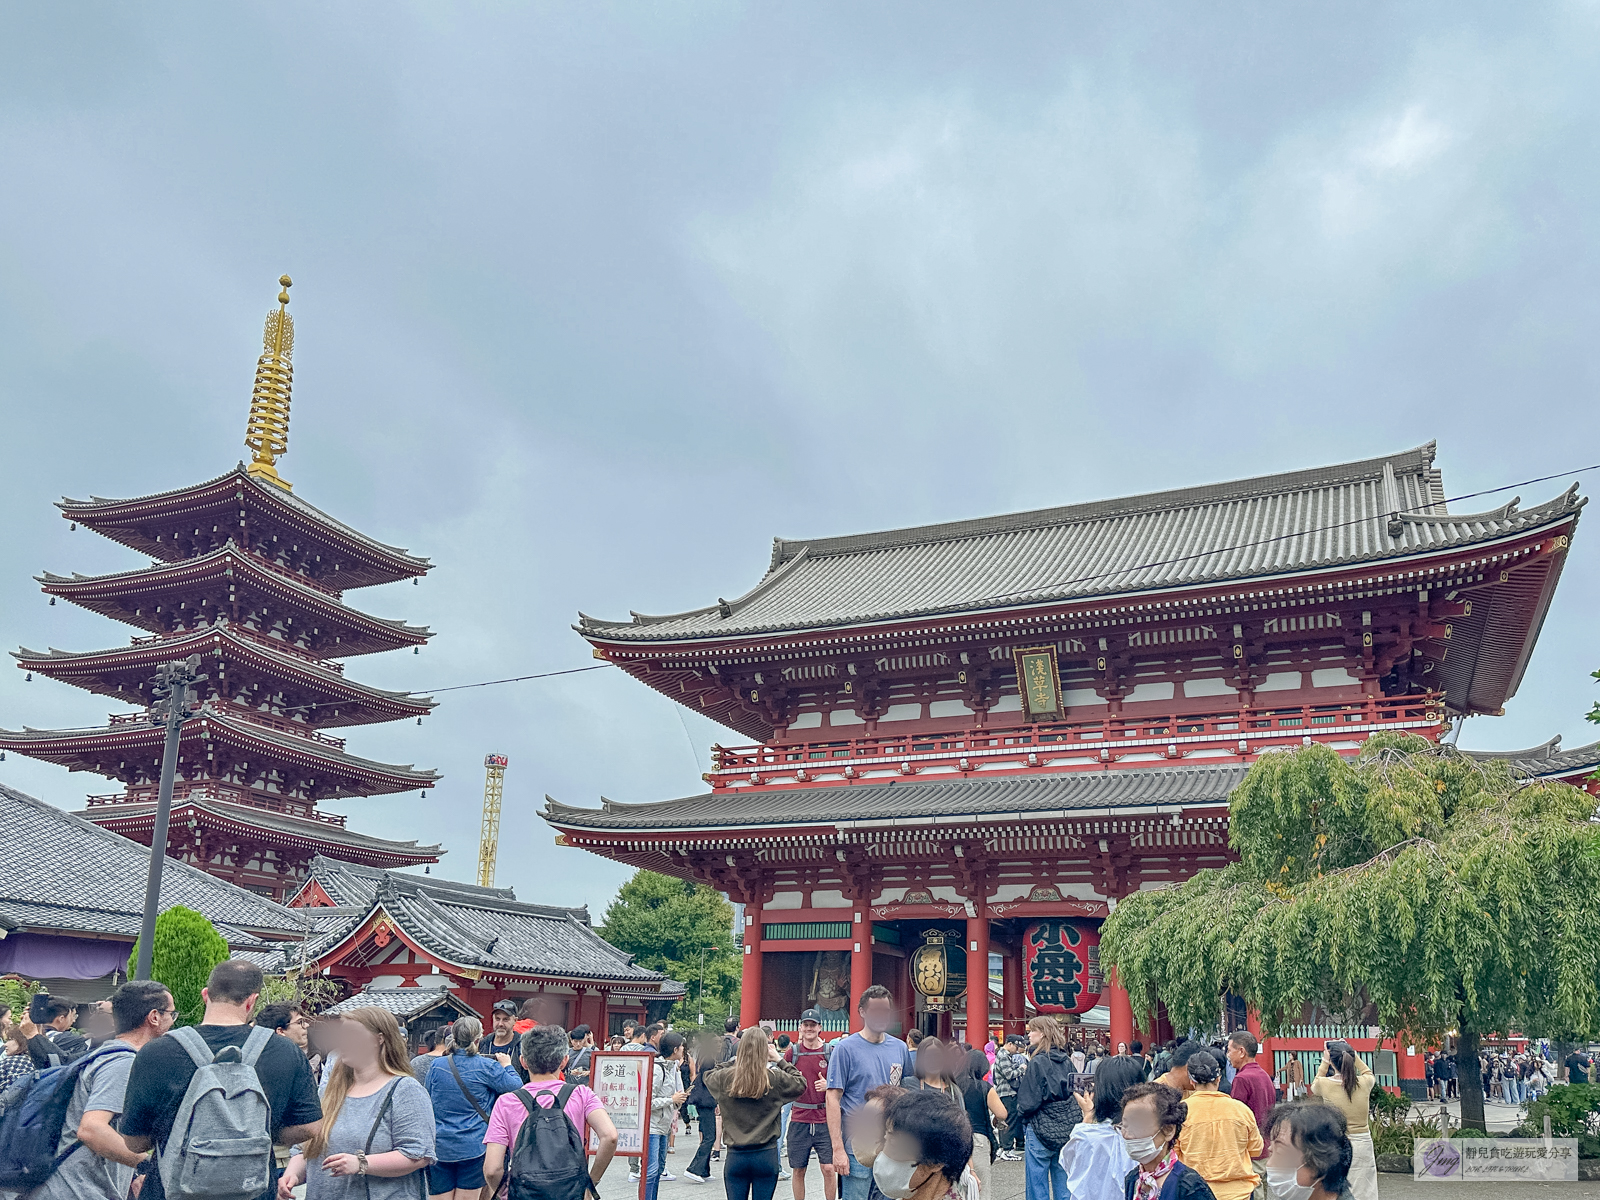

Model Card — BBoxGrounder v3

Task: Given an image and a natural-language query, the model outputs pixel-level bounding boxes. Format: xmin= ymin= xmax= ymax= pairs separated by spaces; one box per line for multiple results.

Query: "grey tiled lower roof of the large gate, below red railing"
xmin=542 ymin=766 xmax=1246 ymax=830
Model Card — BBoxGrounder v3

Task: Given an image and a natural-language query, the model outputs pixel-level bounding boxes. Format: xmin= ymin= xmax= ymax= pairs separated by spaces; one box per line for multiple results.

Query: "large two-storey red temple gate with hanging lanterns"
xmin=544 ymin=443 xmax=1580 ymax=1086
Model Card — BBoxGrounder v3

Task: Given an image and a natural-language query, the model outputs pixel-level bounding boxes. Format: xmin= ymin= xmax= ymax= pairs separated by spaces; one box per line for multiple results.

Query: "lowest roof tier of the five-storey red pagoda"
xmin=77 ymin=794 xmax=445 ymax=867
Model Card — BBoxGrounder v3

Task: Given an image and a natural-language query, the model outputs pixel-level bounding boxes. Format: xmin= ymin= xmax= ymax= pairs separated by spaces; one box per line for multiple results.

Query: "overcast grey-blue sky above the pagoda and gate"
xmin=0 ymin=0 xmax=1600 ymax=917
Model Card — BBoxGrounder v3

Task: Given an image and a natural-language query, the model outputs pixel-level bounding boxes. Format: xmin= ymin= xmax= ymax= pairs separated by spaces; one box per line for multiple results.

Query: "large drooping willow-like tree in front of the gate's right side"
xmin=1101 ymin=734 xmax=1600 ymax=1130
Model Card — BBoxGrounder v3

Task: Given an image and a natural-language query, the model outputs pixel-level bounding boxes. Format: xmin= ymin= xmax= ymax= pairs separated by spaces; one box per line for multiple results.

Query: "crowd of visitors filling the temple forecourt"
xmin=0 ymin=960 xmax=1590 ymax=1200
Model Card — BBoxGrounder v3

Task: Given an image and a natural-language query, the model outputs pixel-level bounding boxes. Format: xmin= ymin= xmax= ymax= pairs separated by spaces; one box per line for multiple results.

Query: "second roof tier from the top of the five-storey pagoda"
xmin=37 ymin=544 xmax=432 ymax=658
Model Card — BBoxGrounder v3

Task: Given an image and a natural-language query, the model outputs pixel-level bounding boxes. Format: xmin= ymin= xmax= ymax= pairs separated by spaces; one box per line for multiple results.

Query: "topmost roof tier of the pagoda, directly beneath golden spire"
xmin=56 ymin=464 xmax=432 ymax=590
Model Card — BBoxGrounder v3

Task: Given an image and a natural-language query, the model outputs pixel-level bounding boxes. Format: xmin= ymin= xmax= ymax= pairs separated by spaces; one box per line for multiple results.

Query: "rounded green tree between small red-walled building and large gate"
xmin=600 ymin=870 xmax=742 ymax=1026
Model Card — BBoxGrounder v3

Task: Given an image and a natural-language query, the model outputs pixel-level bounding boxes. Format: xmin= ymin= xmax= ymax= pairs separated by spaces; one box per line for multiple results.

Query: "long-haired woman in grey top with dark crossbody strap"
xmin=278 ymin=1008 xmax=434 ymax=1200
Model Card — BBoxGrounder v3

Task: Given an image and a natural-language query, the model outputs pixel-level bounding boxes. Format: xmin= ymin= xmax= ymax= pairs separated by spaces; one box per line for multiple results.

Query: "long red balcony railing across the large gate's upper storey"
xmin=706 ymin=693 xmax=1445 ymax=787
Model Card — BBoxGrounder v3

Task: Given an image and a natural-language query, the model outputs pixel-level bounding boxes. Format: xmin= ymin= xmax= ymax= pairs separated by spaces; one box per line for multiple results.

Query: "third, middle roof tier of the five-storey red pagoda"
xmin=11 ymin=630 xmax=437 ymax=730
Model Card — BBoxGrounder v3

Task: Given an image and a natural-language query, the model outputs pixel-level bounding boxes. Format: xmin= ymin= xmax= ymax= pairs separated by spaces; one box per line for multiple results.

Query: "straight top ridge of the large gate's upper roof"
xmin=773 ymin=442 xmax=1438 ymax=568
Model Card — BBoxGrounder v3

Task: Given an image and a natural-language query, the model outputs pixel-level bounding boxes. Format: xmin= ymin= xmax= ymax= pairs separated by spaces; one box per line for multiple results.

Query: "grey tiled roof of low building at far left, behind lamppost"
xmin=0 ymin=784 xmax=306 ymax=944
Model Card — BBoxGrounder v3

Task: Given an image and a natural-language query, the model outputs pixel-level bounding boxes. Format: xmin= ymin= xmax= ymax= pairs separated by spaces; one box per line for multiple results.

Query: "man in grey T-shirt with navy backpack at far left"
xmin=0 ymin=981 xmax=174 ymax=1200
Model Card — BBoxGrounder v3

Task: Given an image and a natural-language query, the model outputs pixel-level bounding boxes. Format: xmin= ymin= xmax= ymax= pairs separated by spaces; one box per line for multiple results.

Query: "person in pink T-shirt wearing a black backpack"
xmin=483 ymin=1026 xmax=616 ymax=1200
